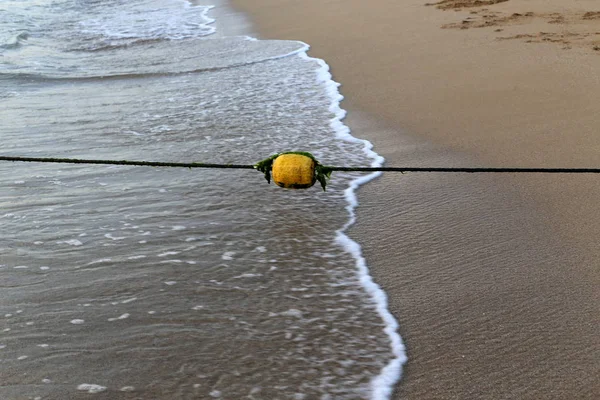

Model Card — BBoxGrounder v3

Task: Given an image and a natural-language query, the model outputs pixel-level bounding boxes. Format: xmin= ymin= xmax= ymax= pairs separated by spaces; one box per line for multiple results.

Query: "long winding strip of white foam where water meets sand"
xmin=300 ymin=45 xmax=407 ymax=400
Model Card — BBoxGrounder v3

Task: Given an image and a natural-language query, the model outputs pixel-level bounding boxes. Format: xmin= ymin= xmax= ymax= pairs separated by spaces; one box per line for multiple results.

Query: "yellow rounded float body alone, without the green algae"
xmin=273 ymin=154 xmax=317 ymax=189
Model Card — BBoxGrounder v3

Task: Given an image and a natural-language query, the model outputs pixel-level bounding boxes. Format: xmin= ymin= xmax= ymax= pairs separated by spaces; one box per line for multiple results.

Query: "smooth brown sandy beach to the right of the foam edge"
xmin=233 ymin=0 xmax=600 ymax=399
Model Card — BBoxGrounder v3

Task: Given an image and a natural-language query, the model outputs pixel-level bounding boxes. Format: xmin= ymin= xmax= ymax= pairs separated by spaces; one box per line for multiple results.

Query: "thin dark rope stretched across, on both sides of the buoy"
xmin=0 ymin=156 xmax=600 ymax=174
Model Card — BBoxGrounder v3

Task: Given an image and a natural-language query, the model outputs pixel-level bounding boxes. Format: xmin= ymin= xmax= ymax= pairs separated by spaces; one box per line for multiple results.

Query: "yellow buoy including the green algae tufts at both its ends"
xmin=254 ymin=152 xmax=331 ymax=191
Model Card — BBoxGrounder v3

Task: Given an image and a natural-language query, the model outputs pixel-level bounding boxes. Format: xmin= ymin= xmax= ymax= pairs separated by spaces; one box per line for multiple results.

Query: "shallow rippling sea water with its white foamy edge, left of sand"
xmin=0 ymin=0 xmax=404 ymax=400
